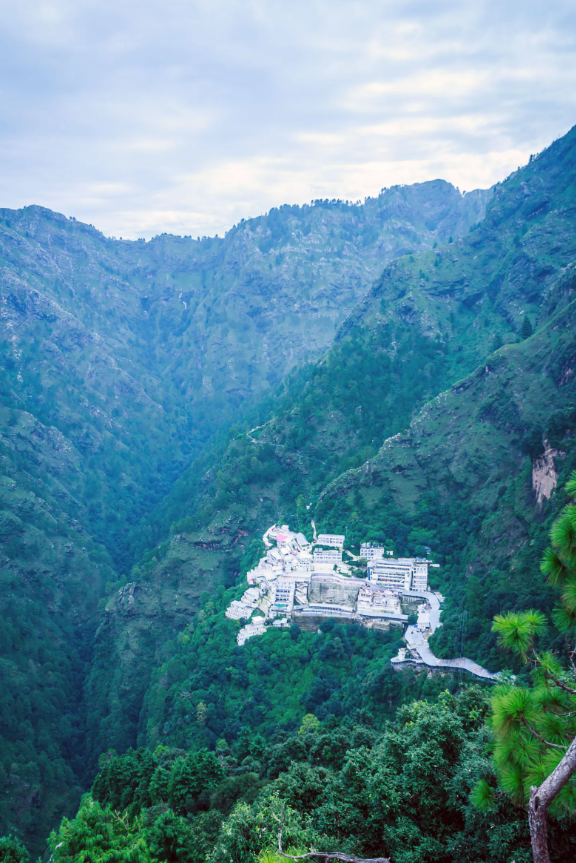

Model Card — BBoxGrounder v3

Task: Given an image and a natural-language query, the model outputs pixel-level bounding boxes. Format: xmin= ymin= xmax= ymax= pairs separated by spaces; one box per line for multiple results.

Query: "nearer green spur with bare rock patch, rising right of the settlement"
xmin=316 ymin=267 xmax=576 ymax=670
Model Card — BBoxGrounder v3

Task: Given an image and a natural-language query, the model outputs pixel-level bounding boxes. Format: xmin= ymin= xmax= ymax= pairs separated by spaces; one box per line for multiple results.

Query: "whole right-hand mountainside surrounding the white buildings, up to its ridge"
xmin=83 ymin=130 xmax=576 ymax=776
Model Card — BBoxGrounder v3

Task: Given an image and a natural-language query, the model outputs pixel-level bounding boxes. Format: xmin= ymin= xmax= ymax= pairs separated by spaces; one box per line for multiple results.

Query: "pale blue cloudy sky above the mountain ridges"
xmin=0 ymin=0 xmax=576 ymax=239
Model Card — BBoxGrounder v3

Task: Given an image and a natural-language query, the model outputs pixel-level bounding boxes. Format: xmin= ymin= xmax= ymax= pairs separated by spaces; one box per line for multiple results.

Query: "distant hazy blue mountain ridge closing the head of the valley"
xmin=0 ymin=181 xmax=491 ymax=567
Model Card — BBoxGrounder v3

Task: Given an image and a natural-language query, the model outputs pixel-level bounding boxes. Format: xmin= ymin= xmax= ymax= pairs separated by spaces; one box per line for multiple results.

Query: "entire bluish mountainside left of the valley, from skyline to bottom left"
xmin=0 ymin=180 xmax=492 ymax=851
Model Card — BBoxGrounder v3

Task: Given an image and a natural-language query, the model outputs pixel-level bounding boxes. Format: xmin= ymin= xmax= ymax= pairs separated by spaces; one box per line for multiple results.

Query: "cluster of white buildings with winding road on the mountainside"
xmin=226 ymin=524 xmax=495 ymax=680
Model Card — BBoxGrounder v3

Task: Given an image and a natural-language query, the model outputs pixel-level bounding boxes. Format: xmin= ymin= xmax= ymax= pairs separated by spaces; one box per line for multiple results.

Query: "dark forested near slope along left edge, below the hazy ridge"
xmin=0 ymin=407 xmax=115 ymax=850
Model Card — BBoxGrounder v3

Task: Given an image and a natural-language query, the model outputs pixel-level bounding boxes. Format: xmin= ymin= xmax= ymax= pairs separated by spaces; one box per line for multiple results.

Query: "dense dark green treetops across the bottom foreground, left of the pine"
xmin=40 ymin=687 xmax=575 ymax=863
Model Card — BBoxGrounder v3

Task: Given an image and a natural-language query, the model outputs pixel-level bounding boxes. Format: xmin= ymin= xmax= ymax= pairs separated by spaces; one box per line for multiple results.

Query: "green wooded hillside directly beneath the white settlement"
xmin=143 ymin=589 xmax=418 ymax=748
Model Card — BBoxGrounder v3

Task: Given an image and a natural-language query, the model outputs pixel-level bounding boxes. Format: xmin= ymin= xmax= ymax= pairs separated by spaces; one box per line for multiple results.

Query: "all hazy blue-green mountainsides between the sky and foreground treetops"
xmin=0 ymin=130 xmax=576 ymax=850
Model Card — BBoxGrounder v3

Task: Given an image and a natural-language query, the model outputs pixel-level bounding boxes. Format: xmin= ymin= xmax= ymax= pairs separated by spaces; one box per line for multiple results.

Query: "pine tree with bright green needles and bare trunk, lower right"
xmin=482 ymin=471 xmax=576 ymax=863
